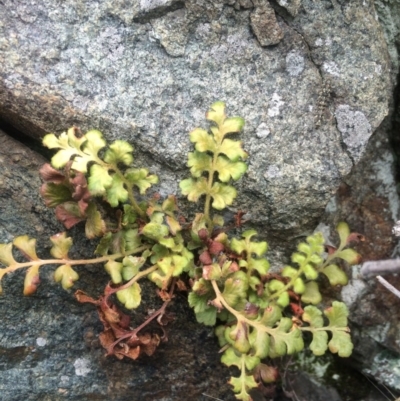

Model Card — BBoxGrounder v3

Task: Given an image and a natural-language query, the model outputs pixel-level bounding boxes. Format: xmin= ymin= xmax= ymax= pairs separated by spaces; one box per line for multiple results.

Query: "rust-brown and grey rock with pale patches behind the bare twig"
xmin=319 ymin=117 xmax=400 ymax=392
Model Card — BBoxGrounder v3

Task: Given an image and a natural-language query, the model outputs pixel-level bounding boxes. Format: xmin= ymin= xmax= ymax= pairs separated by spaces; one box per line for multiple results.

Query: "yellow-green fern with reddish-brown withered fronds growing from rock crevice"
xmin=0 ymin=102 xmax=359 ymax=401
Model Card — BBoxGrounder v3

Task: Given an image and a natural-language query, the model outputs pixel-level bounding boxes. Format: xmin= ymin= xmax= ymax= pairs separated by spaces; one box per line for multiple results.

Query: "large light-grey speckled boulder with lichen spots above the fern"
xmin=0 ymin=0 xmax=391 ymax=247
